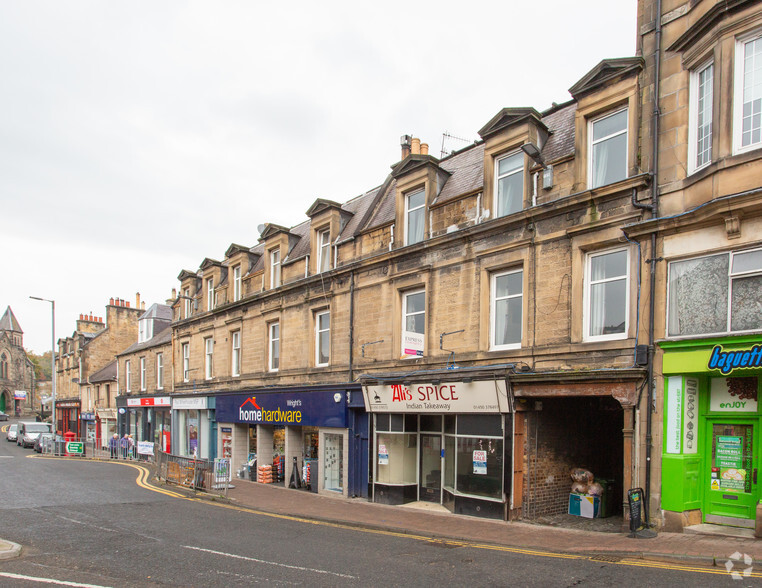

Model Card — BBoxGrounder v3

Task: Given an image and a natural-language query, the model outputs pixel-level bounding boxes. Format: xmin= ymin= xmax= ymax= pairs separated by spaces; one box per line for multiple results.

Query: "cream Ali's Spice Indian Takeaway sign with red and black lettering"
xmin=363 ymin=380 xmax=508 ymax=414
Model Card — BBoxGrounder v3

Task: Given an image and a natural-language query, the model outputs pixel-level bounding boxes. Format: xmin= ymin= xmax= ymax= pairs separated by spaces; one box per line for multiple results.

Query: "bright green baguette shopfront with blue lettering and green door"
xmin=659 ymin=336 xmax=762 ymax=528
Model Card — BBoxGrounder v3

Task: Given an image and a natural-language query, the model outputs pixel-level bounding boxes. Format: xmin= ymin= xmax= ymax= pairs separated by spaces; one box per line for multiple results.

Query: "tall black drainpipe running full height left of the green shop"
xmin=645 ymin=0 xmax=661 ymax=526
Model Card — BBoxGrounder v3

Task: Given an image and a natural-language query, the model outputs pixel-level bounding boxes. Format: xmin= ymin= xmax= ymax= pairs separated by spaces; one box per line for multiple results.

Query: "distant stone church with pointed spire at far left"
xmin=0 ymin=306 xmax=35 ymax=416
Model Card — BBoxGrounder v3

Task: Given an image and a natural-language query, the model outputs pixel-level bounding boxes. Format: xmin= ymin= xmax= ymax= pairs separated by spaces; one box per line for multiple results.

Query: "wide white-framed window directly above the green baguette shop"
xmin=667 ymin=249 xmax=762 ymax=337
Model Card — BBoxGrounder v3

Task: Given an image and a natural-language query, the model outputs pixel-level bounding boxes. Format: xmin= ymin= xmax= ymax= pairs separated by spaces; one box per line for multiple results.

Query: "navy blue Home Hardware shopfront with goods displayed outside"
xmin=215 ymin=386 xmax=368 ymax=496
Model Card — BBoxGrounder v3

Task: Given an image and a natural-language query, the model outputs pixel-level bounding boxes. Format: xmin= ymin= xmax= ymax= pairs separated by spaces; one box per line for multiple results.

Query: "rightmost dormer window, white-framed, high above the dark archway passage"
xmin=588 ymin=108 xmax=627 ymax=188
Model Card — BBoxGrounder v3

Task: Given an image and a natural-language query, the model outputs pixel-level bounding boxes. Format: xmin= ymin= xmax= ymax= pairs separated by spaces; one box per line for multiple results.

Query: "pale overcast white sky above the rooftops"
xmin=0 ymin=0 xmax=636 ymax=353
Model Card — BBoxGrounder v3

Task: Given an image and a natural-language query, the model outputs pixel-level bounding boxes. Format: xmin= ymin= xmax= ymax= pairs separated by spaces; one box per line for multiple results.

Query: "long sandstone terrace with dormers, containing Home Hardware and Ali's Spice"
xmin=172 ymin=49 xmax=651 ymax=518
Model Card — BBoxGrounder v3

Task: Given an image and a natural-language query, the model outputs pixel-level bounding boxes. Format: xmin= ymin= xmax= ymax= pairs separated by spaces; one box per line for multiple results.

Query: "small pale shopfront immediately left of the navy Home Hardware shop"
xmin=171 ymin=396 xmax=217 ymax=459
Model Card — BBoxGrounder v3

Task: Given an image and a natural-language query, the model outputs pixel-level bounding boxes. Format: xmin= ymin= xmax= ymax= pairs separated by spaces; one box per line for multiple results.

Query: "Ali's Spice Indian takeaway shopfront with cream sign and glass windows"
xmin=363 ymin=380 xmax=513 ymax=519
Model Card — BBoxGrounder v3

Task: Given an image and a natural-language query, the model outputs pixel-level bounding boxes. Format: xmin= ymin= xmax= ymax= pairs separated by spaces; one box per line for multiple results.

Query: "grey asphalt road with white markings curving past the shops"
xmin=0 ymin=423 xmax=759 ymax=587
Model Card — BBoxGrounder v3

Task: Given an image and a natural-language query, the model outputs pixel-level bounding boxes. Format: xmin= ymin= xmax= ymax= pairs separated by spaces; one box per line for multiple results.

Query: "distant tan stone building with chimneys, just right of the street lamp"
xmin=56 ymin=294 xmax=144 ymax=437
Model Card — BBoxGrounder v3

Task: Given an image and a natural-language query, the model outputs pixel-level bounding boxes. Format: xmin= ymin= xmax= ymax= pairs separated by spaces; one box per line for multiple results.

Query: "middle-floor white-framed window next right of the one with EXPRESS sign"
xmin=490 ymin=269 xmax=524 ymax=349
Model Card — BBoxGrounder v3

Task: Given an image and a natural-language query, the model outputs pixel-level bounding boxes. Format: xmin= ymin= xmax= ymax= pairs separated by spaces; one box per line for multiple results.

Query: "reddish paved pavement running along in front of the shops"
xmin=203 ymin=479 xmax=762 ymax=565
